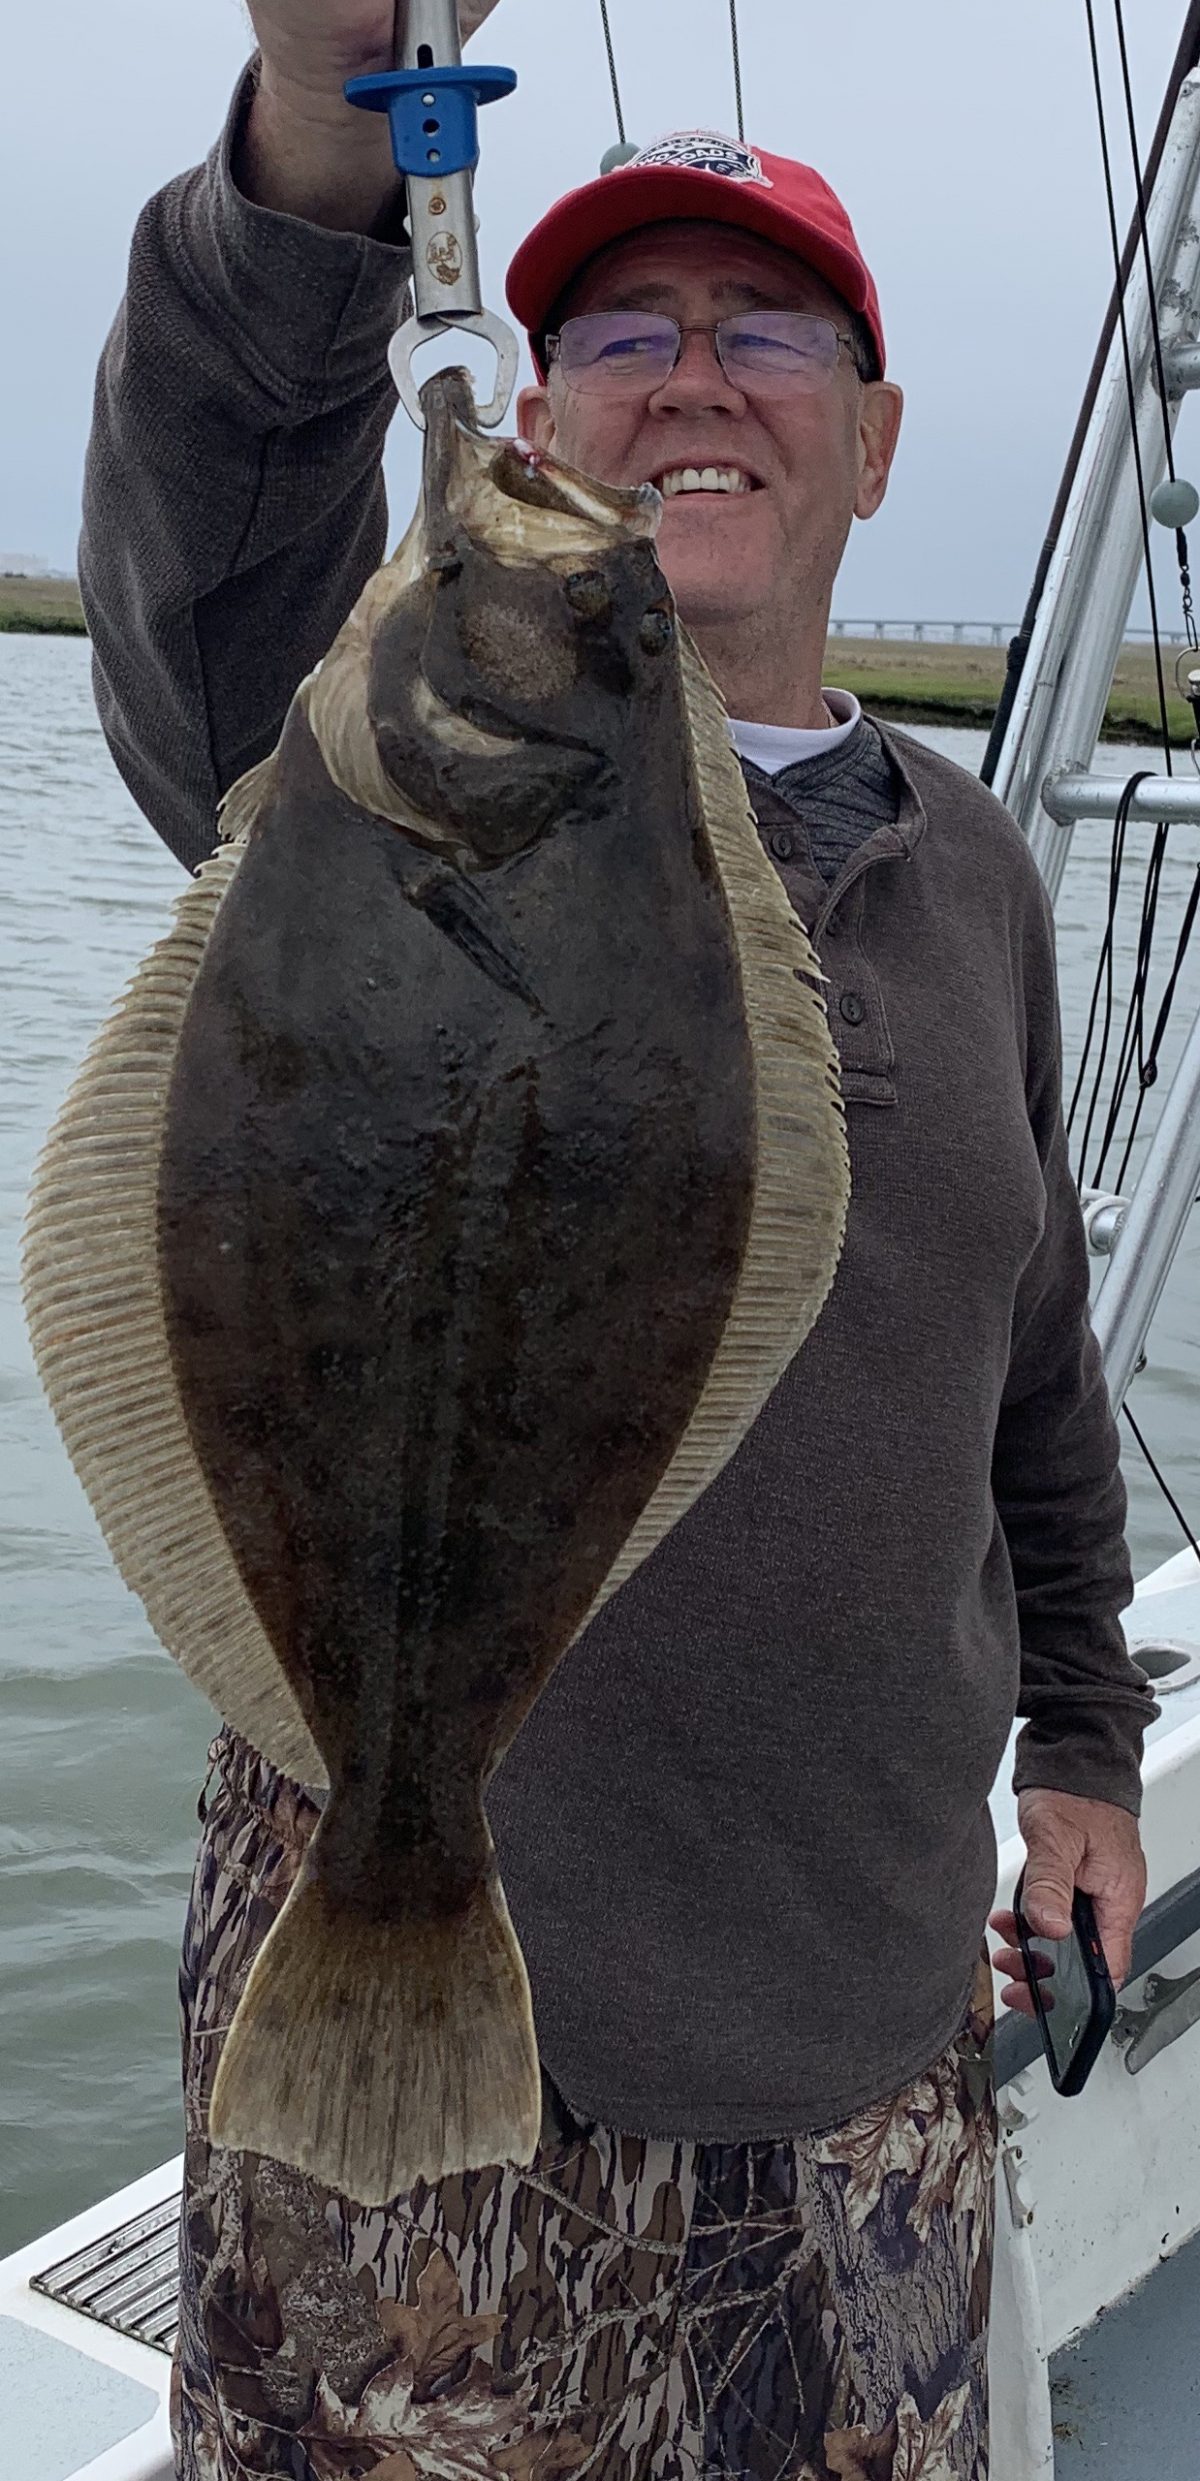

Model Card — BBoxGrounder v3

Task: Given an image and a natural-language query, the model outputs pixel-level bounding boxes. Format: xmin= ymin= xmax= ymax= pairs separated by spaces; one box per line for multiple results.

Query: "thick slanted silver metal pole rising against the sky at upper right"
xmin=994 ymin=79 xmax=1200 ymax=903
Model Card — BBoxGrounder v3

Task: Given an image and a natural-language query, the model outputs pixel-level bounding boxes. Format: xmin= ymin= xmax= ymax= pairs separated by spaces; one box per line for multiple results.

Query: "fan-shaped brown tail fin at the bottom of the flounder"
xmin=208 ymin=1843 xmax=540 ymax=2206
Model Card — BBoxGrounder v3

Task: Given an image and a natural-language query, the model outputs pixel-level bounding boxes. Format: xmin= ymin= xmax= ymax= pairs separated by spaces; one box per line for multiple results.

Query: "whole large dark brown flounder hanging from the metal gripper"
xmin=25 ymin=372 xmax=848 ymax=2203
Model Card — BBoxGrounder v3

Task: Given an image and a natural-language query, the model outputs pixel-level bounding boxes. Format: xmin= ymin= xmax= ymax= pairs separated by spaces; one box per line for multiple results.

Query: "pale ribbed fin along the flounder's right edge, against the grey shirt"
xmin=580 ymin=630 xmax=850 ymax=1635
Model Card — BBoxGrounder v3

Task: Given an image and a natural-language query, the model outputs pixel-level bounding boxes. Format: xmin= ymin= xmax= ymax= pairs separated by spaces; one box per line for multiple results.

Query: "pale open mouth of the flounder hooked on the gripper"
xmin=421 ymin=370 xmax=662 ymax=568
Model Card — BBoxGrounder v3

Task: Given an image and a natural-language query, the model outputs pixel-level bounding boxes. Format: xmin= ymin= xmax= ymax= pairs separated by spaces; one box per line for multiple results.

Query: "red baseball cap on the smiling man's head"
xmin=508 ymin=129 xmax=885 ymax=380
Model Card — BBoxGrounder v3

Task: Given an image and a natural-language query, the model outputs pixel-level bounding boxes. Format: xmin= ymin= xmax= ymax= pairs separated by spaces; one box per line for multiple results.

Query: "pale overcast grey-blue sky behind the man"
xmin=0 ymin=0 xmax=1200 ymax=625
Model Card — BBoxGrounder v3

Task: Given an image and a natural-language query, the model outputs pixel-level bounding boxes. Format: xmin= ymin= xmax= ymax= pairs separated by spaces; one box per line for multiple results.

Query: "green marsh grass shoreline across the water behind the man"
xmin=0 ymin=578 xmax=1193 ymax=749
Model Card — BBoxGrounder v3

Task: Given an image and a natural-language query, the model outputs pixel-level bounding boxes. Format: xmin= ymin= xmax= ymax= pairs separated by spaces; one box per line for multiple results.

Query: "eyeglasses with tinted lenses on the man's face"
xmin=545 ymin=310 xmax=858 ymax=397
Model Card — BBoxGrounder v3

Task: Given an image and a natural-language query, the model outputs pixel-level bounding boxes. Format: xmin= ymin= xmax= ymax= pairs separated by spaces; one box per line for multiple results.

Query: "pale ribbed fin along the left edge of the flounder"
xmin=22 ymin=788 xmax=327 ymax=1786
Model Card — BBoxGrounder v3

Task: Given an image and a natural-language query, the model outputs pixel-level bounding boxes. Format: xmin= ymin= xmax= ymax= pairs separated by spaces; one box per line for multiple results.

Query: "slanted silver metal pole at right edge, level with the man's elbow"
xmin=1091 ymin=1015 xmax=1200 ymax=1412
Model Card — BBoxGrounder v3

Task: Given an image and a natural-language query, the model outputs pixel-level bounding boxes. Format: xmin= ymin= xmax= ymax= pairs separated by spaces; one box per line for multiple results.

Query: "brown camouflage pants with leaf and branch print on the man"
xmin=174 ymin=1732 xmax=994 ymax=2481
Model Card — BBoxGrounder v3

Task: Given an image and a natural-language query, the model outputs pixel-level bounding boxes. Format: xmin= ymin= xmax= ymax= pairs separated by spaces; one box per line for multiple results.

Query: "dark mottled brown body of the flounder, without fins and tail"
xmin=159 ymin=483 xmax=756 ymax=1918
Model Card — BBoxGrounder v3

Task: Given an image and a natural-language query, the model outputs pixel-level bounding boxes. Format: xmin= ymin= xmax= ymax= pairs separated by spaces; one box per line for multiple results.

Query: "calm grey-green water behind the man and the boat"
xmin=0 ymin=638 xmax=1200 ymax=2255
